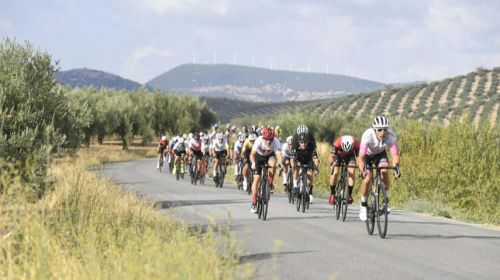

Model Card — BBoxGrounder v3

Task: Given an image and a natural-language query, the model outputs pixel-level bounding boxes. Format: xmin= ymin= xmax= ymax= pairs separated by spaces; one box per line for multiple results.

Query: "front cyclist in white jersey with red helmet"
xmin=250 ymin=127 xmax=281 ymax=213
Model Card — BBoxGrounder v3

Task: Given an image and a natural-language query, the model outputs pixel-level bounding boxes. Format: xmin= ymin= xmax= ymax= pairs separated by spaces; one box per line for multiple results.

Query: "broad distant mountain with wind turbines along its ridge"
xmin=146 ymin=64 xmax=384 ymax=102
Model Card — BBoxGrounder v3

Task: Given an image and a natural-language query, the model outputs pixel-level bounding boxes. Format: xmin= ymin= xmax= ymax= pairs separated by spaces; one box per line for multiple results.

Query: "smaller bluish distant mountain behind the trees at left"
xmin=56 ymin=68 xmax=142 ymax=90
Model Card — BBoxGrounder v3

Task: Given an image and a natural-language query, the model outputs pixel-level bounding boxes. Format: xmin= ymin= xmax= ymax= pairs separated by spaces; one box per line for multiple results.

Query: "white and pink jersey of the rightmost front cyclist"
xmin=359 ymin=128 xmax=398 ymax=156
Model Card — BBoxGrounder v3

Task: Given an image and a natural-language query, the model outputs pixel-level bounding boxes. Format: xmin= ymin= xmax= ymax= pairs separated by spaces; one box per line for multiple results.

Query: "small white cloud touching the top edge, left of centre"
xmin=129 ymin=0 xmax=229 ymax=16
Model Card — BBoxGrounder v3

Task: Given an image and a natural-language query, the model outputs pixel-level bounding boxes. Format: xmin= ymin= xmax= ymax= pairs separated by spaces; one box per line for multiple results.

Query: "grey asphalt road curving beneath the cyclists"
xmin=100 ymin=159 xmax=500 ymax=280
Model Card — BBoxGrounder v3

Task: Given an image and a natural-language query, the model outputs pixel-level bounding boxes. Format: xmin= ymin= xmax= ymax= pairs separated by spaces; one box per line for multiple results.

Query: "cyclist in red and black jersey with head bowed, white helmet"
xmin=328 ymin=135 xmax=359 ymax=205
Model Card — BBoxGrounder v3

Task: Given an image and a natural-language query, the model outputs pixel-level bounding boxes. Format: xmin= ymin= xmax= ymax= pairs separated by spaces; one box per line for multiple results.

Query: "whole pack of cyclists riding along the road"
xmin=157 ymin=116 xmax=401 ymax=221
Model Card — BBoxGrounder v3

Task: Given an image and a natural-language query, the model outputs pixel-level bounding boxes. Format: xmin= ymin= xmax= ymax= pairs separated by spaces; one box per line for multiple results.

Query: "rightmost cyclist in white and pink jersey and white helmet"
xmin=358 ymin=116 xmax=401 ymax=221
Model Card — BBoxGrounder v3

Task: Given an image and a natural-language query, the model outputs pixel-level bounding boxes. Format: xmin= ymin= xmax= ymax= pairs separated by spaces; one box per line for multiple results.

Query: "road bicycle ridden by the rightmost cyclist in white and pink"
xmin=366 ymin=166 xmax=396 ymax=238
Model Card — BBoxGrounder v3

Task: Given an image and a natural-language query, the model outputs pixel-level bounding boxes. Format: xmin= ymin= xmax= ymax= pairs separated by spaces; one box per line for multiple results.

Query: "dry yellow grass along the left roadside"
xmin=0 ymin=146 xmax=250 ymax=279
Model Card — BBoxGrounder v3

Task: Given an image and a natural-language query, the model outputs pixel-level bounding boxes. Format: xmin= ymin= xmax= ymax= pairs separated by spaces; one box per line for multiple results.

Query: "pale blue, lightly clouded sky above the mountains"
xmin=0 ymin=0 xmax=500 ymax=83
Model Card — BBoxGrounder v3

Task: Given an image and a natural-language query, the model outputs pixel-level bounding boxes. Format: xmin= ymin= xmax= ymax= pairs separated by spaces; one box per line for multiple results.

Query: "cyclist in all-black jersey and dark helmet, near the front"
xmin=290 ymin=125 xmax=319 ymax=203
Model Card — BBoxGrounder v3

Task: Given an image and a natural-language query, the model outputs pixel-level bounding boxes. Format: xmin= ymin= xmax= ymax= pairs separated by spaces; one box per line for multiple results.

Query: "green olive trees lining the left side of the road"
xmin=0 ymin=38 xmax=216 ymax=199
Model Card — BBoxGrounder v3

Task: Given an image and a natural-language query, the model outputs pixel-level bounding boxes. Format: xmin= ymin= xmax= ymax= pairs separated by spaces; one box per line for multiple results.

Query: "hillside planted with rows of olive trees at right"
xmin=209 ymin=67 xmax=500 ymax=125
